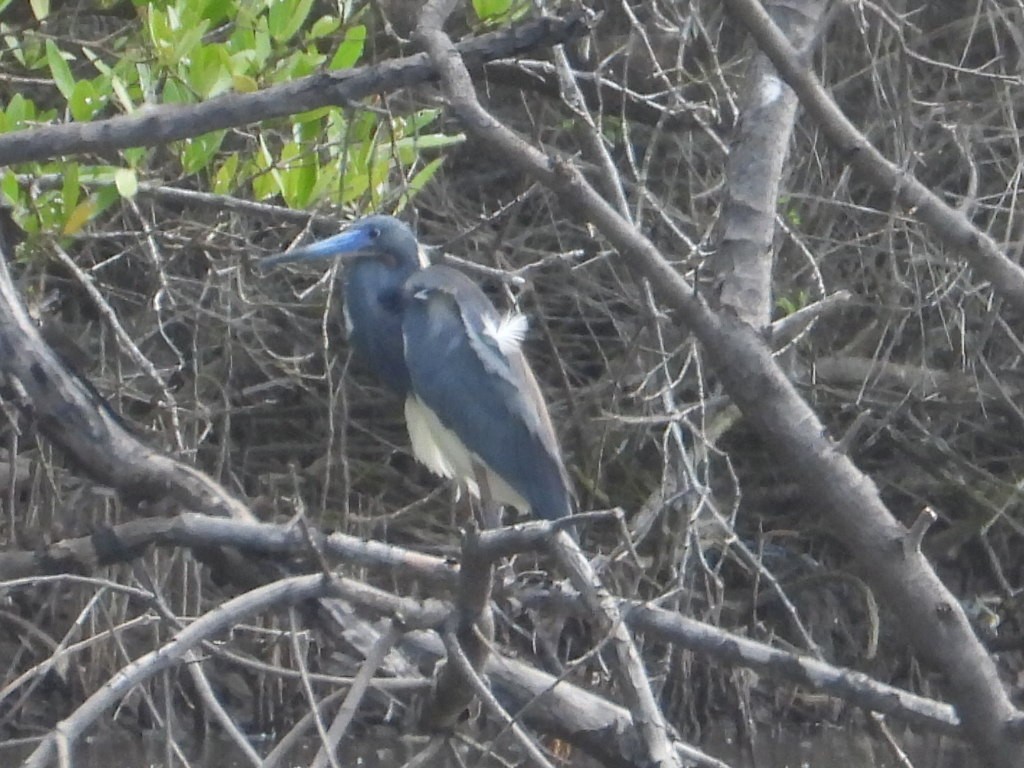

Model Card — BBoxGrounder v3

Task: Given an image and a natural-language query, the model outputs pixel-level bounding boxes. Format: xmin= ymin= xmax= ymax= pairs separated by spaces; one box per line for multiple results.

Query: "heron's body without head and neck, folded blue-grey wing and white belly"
xmin=401 ymin=265 xmax=572 ymax=519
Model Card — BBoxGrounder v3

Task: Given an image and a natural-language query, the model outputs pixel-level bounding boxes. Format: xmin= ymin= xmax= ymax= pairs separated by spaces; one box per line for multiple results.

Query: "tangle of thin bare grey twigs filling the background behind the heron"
xmin=0 ymin=0 xmax=1024 ymax=764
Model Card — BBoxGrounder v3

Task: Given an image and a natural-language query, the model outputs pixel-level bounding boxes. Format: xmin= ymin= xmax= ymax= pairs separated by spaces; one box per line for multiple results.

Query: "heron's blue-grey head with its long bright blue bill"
xmin=260 ymin=216 xmax=427 ymax=279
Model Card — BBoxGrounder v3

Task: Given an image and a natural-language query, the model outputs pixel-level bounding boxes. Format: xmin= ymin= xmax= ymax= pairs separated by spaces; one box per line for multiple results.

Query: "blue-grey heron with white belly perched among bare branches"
xmin=261 ymin=215 xmax=575 ymax=520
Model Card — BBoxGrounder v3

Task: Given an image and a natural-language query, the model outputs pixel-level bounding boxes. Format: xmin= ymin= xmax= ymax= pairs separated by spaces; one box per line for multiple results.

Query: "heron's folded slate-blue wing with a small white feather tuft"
xmin=402 ymin=267 xmax=571 ymax=517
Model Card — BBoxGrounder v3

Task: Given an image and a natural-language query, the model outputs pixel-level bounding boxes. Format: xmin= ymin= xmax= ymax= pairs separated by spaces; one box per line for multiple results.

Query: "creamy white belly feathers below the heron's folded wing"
xmin=406 ymin=395 xmax=530 ymax=514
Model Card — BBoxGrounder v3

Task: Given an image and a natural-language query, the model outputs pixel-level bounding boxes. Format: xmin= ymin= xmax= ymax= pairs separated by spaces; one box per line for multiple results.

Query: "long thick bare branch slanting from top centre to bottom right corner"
xmin=407 ymin=7 xmax=1024 ymax=768
